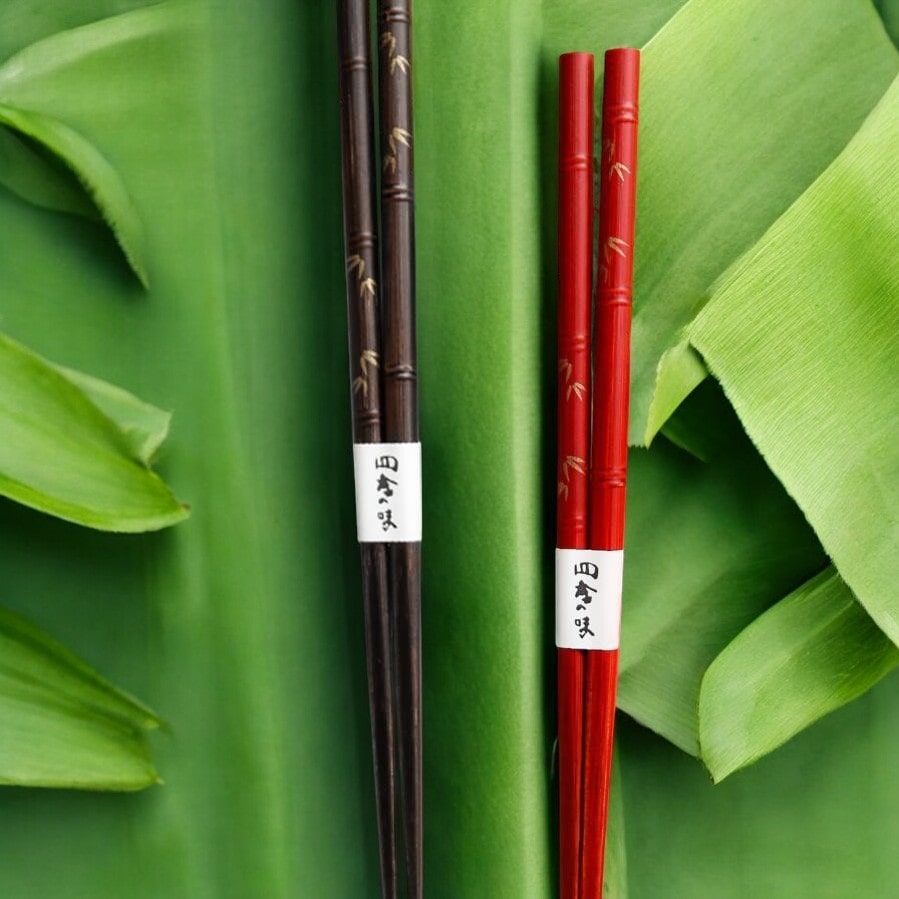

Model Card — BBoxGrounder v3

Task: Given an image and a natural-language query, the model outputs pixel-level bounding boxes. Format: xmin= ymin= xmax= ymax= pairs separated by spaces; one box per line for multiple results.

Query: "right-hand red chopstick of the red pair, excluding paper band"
xmin=580 ymin=49 xmax=640 ymax=899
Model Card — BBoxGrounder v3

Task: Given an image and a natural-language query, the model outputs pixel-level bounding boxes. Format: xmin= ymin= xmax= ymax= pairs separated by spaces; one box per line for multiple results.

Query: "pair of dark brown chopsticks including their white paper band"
xmin=337 ymin=0 xmax=423 ymax=899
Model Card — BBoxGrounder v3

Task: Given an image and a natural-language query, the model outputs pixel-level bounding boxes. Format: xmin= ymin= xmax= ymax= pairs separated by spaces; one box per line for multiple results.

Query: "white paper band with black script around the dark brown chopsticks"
xmin=353 ymin=443 xmax=421 ymax=543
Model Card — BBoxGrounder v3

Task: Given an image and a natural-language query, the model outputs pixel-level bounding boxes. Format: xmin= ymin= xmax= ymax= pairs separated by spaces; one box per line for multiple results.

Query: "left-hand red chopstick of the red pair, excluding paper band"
xmin=556 ymin=53 xmax=594 ymax=899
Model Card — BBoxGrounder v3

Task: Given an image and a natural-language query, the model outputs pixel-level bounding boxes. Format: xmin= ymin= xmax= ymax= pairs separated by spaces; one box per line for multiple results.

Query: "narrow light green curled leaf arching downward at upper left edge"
xmin=0 ymin=105 xmax=149 ymax=287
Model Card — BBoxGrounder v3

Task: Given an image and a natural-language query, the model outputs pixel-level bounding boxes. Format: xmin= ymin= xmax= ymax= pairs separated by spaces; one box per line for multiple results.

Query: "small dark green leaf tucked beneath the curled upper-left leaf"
xmin=0 ymin=128 xmax=97 ymax=218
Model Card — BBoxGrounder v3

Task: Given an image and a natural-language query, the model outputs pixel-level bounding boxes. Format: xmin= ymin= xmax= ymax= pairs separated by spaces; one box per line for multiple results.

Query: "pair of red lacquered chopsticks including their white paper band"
xmin=556 ymin=49 xmax=640 ymax=899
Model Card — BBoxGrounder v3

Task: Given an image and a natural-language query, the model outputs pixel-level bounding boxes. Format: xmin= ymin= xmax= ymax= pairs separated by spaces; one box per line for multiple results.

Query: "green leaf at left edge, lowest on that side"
xmin=0 ymin=609 xmax=160 ymax=790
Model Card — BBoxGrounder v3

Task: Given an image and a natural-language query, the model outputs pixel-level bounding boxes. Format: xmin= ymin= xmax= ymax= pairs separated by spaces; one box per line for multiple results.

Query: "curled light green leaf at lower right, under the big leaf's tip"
xmin=699 ymin=567 xmax=899 ymax=782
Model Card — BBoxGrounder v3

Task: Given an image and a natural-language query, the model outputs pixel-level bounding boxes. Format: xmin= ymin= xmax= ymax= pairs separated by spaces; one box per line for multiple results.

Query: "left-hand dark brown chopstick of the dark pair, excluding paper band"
xmin=337 ymin=0 xmax=397 ymax=899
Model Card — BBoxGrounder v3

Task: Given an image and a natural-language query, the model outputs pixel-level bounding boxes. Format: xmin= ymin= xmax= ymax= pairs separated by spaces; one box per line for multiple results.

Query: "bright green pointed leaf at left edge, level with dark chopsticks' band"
xmin=0 ymin=336 xmax=187 ymax=531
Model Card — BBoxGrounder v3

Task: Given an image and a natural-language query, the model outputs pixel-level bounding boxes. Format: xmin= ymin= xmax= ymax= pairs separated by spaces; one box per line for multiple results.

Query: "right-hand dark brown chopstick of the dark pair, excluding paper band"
xmin=378 ymin=0 xmax=423 ymax=899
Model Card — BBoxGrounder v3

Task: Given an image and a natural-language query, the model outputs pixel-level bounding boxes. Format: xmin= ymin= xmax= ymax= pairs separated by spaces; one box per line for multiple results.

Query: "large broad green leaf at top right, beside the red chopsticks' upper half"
xmin=631 ymin=0 xmax=899 ymax=444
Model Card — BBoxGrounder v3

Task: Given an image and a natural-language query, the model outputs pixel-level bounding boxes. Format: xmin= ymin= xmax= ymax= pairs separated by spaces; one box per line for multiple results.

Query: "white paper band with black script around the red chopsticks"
xmin=556 ymin=549 xmax=624 ymax=649
